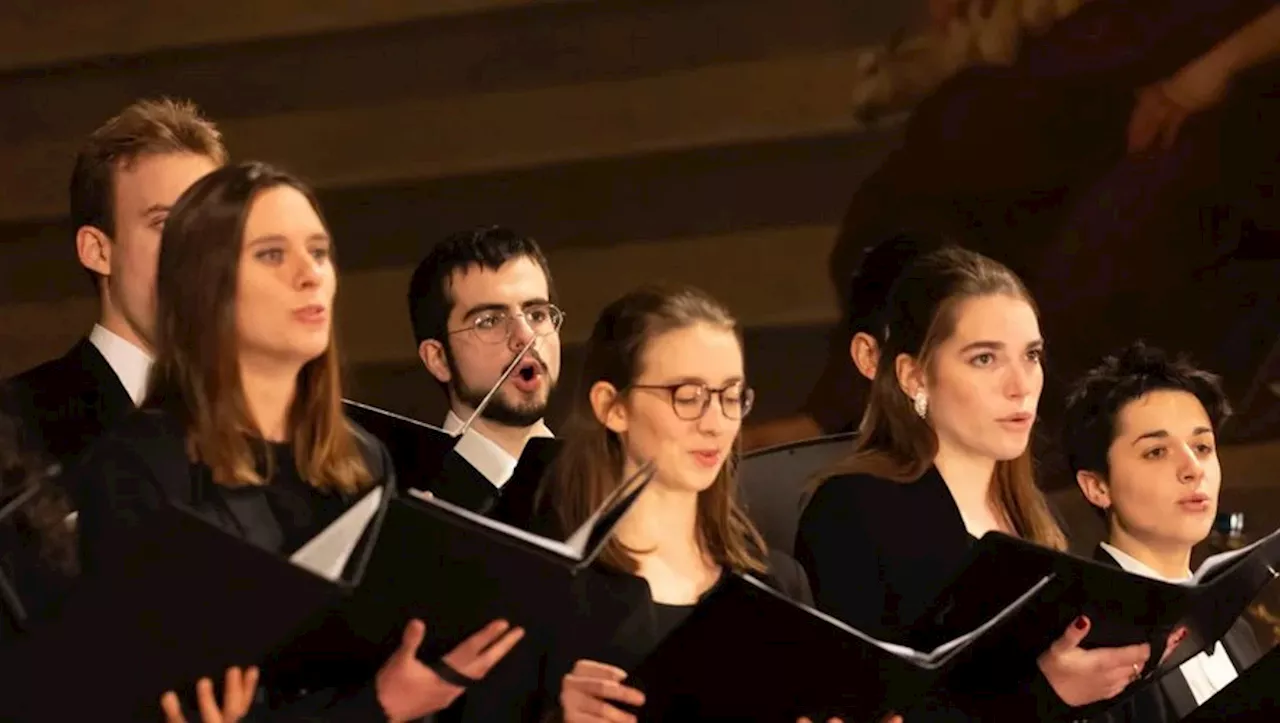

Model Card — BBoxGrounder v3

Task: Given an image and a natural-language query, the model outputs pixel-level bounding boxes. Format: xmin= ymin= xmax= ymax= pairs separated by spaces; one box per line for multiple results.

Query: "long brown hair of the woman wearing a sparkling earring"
xmin=817 ymin=246 xmax=1066 ymax=549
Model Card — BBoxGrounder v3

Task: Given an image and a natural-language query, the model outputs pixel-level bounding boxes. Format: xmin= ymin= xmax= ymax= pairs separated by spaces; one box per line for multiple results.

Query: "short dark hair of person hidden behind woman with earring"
xmin=845 ymin=229 xmax=955 ymax=343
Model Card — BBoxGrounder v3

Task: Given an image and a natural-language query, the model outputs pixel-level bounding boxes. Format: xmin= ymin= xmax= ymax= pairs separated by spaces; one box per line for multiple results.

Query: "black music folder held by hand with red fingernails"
xmin=908 ymin=530 xmax=1280 ymax=703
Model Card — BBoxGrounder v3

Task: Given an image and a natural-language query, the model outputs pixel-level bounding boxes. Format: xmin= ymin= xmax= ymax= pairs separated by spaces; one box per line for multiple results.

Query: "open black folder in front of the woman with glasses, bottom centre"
xmin=626 ymin=573 xmax=1051 ymax=723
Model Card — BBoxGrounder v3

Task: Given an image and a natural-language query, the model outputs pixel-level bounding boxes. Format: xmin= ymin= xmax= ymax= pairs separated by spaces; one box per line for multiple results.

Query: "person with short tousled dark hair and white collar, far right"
xmin=1062 ymin=342 xmax=1261 ymax=723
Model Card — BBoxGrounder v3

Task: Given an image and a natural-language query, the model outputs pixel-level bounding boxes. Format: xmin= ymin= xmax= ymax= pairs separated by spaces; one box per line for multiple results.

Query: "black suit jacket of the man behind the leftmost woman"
xmin=6 ymin=338 xmax=134 ymax=502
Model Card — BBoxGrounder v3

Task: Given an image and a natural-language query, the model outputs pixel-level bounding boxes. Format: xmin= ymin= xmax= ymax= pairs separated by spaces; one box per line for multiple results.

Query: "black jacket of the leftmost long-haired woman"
xmin=68 ymin=409 xmax=396 ymax=723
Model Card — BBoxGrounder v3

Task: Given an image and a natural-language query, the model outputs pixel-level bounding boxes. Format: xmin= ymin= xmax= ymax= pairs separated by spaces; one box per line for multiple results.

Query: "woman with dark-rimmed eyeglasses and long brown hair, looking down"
xmin=455 ymin=287 xmax=906 ymax=723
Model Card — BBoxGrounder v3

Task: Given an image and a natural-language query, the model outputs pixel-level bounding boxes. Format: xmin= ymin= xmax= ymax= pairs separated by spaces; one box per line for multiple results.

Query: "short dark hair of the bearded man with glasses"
xmin=408 ymin=226 xmax=556 ymax=344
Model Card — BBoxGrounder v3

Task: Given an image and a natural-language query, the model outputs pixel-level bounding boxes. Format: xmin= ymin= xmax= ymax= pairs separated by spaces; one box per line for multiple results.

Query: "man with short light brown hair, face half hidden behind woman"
xmin=10 ymin=99 xmax=227 ymax=502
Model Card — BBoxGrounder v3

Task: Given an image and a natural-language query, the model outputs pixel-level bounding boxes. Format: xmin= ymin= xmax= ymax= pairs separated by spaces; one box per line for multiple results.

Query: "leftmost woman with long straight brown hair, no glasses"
xmin=79 ymin=163 xmax=522 ymax=722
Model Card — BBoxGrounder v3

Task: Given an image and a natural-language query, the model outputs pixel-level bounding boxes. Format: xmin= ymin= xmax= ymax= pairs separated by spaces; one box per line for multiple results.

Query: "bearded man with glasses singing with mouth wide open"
xmin=408 ymin=226 xmax=564 ymax=511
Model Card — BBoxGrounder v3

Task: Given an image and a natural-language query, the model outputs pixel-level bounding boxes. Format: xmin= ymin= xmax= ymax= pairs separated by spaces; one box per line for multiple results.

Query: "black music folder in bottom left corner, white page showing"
xmin=0 ymin=488 xmax=384 ymax=720
